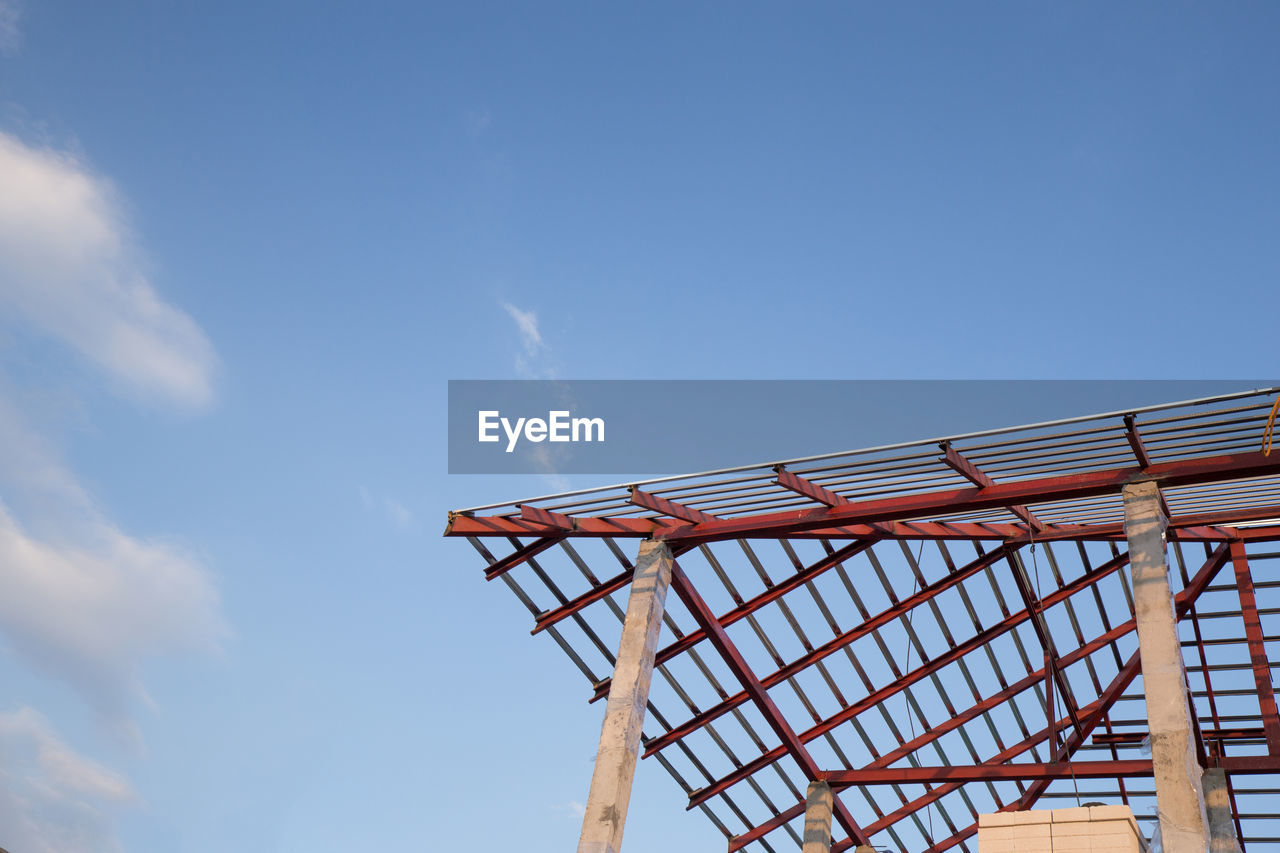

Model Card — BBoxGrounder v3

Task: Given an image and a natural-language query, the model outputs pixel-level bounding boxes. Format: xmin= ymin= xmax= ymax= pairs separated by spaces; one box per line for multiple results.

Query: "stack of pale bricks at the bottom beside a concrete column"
xmin=978 ymin=806 xmax=1147 ymax=853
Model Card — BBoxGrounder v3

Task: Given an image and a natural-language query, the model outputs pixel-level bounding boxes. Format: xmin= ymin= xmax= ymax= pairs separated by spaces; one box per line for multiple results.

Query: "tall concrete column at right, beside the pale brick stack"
xmin=1124 ymin=483 xmax=1208 ymax=853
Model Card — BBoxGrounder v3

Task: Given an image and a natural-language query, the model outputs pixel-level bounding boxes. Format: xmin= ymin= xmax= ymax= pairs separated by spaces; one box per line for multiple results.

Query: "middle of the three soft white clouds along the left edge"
xmin=0 ymin=400 xmax=227 ymax=743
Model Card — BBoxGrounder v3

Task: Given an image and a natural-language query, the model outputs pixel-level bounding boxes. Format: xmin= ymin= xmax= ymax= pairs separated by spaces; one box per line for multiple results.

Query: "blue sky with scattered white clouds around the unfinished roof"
xmin=0 ymin=0 xmax=1280 ymax=853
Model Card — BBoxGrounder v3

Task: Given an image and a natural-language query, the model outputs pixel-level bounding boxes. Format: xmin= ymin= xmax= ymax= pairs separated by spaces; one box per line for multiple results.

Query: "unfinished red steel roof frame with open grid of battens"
xmin=447 ymin=388 xmax=1280 ymax=853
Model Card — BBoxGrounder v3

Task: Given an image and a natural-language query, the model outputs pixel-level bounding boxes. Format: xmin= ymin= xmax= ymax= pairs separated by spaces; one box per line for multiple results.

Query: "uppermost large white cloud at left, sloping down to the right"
xmin=0 ymin=133 xmax=216 ymax=407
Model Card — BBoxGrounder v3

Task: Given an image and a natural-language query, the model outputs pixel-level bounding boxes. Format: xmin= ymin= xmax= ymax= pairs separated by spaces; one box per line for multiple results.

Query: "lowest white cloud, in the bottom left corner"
xmin=0 ymin=708 xmax=137 ymax=853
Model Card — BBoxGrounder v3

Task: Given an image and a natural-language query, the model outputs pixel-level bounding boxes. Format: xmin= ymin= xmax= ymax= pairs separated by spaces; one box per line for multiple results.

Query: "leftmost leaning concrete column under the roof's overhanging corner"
xmin=577 ymin=539 xmax=673 ymax=853
